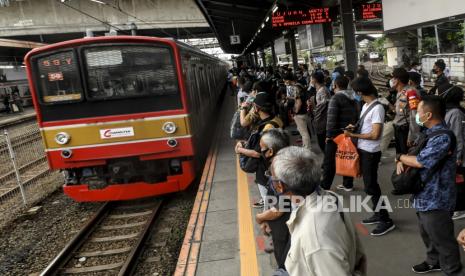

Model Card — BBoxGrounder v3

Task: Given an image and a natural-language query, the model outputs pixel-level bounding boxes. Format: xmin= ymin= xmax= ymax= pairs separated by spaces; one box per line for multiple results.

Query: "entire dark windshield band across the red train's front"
xmin=33 ymin=44 xmax=182 ymax=121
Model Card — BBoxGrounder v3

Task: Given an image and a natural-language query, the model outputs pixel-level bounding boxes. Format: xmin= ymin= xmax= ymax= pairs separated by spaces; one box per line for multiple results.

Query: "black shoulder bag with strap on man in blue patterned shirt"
xmin=391 ymin=130 xmax=456 ymax=195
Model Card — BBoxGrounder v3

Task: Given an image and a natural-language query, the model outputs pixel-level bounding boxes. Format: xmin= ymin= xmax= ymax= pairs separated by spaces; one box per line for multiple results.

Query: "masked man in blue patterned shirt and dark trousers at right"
xmin=396 ymin=96 xmax=464 ymax=275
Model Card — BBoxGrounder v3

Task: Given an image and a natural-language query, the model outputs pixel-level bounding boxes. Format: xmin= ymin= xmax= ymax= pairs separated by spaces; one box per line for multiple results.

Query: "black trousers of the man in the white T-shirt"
xmin=358 ymin=149 xmax=391 ymax=222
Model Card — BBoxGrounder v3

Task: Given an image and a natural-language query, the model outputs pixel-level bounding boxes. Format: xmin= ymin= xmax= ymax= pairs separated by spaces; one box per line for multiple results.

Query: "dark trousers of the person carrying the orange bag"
xmin=321 ymin=140 xmax=354 ymax=190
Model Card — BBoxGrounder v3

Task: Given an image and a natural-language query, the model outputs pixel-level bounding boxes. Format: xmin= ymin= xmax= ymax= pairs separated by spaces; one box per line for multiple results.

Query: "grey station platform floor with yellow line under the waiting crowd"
xmin=174 ymin=95 xmax=465 ymax=276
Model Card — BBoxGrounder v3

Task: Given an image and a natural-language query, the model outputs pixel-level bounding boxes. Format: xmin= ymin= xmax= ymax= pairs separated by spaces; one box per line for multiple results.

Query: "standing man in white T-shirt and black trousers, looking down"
xmin=344 ymin=77 xmax=396 ymax=236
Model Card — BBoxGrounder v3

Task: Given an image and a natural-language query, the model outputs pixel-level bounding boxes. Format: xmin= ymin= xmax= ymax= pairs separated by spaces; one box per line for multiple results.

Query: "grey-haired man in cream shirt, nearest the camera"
xmin=271 ymin=146 xmax=366 ymax=276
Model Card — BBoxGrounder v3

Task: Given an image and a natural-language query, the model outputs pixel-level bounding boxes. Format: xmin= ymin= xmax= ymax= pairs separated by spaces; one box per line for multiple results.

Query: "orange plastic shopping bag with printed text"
xmin=334 ymin=134 xmax=360 ymax=177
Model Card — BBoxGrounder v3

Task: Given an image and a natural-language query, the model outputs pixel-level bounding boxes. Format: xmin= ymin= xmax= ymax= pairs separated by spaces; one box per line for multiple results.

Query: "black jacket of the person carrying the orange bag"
xmin=326 ymin=92 xmax=359 ymax=138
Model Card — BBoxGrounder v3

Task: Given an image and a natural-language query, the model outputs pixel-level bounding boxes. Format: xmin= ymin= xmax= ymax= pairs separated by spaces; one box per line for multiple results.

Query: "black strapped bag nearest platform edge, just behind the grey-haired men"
xmin=239 ymin=116 xmax=279 ymax=173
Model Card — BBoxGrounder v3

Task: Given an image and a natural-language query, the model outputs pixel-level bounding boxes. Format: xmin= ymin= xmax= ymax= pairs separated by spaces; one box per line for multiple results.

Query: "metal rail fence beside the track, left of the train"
xmin=0 ymin=124 xmax=64 ymax=227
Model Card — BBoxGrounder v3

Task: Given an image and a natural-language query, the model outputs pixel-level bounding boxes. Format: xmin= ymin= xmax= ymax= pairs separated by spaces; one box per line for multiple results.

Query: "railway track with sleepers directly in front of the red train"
xmin=40 ymin=199 xmax=163 ymax=276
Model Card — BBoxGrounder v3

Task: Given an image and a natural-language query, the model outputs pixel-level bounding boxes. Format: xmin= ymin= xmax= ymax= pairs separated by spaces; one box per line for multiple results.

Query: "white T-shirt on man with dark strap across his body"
xmin=357 ymin=100 xmax=384 ymax=152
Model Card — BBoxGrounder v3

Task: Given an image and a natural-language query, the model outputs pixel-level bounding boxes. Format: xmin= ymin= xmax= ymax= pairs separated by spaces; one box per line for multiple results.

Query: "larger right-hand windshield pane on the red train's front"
xmin=83 ymin=45 xmax=180 ymax=101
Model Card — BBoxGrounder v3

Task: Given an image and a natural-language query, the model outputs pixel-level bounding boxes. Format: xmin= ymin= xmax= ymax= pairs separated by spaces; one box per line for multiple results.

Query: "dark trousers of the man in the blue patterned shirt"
xmin=417 ymin=210 xmax=463 ymax=275
